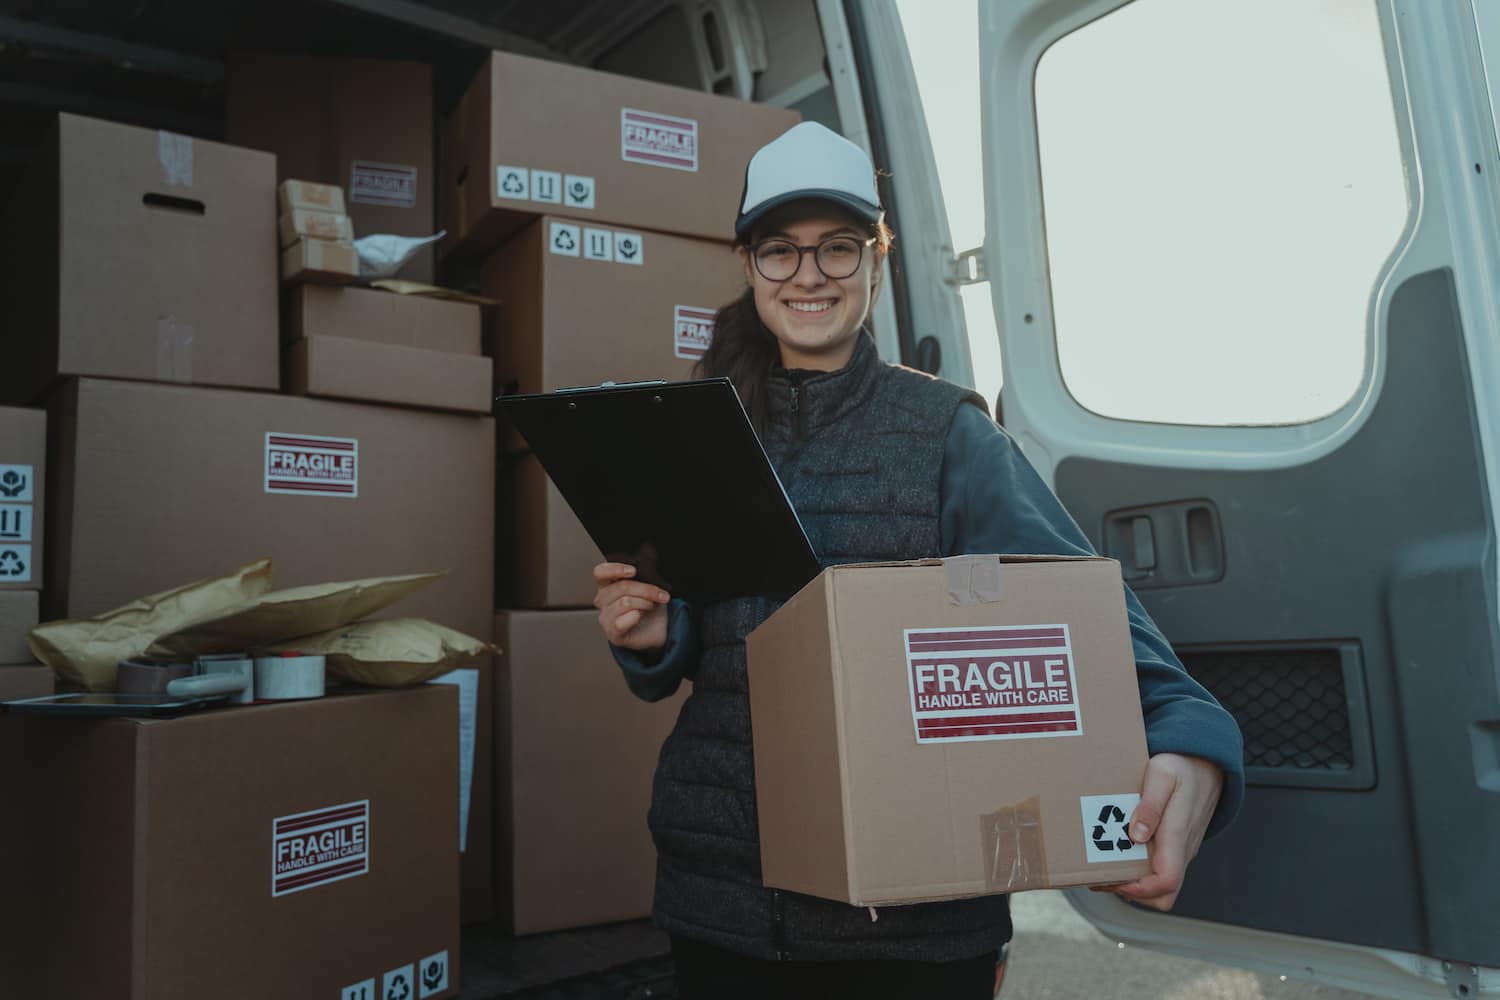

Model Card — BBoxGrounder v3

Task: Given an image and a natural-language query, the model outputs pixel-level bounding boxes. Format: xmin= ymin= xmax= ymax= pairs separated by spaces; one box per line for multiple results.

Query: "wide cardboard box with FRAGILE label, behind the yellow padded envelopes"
xmin=44 ymin=379 xmax=495 ymax=919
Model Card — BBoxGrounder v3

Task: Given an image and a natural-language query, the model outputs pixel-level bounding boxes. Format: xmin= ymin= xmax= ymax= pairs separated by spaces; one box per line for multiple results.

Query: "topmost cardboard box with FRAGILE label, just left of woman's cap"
xmin=441 ymin=52 xmax=801 ymax=256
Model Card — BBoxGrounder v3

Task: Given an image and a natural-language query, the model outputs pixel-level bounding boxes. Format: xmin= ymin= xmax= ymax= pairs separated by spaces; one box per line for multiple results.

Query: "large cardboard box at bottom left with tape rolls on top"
xmin=0 ymin=685 xmax=459 ymax=1000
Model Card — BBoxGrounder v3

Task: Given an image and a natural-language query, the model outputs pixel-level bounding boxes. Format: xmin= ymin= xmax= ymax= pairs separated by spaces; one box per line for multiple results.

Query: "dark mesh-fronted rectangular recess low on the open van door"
xmin=1179 ymin=649 xmax=1355 ymax=772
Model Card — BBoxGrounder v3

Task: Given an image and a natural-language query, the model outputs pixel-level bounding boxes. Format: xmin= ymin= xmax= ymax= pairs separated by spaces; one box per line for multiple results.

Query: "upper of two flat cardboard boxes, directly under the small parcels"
xmin=285 ymin=288 xmax=489 ymax=353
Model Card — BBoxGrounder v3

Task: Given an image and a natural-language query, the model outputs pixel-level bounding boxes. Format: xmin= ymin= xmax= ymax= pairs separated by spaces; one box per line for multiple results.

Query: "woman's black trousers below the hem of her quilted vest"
xmin=672 ymin=936 xmax=999 ymax=1000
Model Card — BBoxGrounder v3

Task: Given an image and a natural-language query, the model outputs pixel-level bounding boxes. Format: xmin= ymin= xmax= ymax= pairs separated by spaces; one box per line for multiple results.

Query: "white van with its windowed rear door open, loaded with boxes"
xmin=0 ymin=0 xmax=1500 ymax=997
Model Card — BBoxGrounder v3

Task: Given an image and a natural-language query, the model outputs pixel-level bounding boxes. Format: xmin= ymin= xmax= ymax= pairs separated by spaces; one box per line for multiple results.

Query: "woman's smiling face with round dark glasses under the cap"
xmin=743 ymin=201 xmax=885 ymax=372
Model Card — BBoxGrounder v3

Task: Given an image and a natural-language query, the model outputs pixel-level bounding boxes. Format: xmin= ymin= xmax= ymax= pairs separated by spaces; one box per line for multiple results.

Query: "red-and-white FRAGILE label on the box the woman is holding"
xmin=906 ymin=625 xmax=1083 ymax=744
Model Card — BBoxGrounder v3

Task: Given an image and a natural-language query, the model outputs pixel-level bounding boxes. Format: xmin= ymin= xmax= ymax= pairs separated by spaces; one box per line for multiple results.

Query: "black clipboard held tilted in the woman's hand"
xmin=498 ymin=378 xmax=821 ymax=604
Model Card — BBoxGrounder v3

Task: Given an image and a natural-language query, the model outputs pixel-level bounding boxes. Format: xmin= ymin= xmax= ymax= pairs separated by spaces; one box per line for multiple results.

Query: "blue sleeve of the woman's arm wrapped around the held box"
xmin=941 ymin=406 xmax=1245 ymax=837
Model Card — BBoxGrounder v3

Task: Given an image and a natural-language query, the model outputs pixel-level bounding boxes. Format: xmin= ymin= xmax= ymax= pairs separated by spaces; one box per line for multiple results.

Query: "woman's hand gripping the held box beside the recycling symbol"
xmin=1103 ymin=754 xmax=1224 ymax=912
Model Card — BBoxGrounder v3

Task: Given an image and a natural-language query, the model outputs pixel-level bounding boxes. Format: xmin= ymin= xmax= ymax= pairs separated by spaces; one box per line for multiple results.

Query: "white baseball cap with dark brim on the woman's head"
xmin=735 ymin=121 xmax=885 ymax=240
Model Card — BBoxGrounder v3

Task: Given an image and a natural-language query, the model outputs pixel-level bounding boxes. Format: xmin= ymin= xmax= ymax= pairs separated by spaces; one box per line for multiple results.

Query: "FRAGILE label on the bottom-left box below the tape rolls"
xmin=272 ymin=799 xmax=371 ymax=897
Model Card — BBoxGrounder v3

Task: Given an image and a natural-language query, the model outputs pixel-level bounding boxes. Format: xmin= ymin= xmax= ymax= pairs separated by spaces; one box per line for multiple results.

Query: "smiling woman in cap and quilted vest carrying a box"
xmin=594 ymin=123 xmax=1245 ymax=1000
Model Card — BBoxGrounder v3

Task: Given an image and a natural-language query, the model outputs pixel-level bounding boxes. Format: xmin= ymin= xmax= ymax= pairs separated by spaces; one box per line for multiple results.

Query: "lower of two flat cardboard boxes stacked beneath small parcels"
xmin=287 ymin=337 xmax=494 ymax=414
